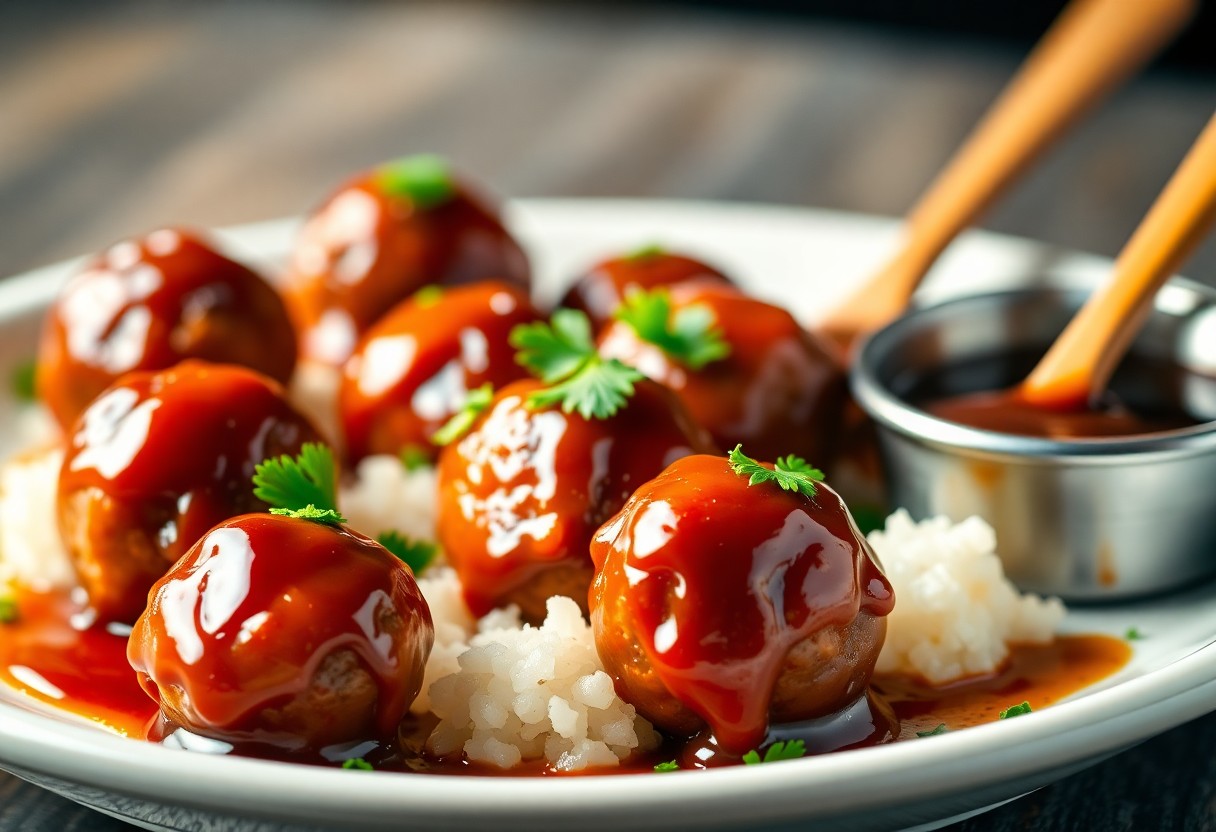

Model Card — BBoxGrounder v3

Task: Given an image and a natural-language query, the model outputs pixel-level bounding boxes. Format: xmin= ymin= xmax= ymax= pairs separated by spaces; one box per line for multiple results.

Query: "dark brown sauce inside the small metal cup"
xmin=903 ymin=350 xmax=1216 ymax=439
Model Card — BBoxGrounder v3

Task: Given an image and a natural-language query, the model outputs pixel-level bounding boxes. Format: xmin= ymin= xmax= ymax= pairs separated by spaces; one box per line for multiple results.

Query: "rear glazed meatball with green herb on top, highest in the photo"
xmin=285 ymin=157 xmax=530 ymax=365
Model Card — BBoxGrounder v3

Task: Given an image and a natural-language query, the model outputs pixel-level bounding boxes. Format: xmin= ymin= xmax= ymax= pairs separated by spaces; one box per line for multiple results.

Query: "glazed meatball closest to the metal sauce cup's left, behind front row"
xmin=599 ymin=282 xmax=846 ymax=466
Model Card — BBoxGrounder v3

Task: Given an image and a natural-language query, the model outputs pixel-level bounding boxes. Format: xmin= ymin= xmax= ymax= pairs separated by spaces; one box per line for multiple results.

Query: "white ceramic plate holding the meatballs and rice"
xmin=0 ymin=201 xmax=1216 ymax=832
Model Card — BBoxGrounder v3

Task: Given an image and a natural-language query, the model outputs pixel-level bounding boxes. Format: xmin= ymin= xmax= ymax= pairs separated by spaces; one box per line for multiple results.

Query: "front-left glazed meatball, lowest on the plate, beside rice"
xmin=128 ymin=515 xmax=434 ymax=757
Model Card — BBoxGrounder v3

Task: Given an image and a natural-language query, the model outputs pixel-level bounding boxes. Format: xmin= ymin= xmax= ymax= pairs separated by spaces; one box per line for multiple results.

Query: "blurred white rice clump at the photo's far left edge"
xmin=0 ymin=448 xmax=75 ymax=592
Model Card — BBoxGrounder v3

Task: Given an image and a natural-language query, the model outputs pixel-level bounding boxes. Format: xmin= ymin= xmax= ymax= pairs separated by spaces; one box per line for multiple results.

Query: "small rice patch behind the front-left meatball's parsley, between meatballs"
xmin=338 ymin=455 xmax=437 ymax=540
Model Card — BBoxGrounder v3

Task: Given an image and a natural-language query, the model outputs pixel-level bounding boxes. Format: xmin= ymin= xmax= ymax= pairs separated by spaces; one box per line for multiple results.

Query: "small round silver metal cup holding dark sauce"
xmin=851 ymin=280 xmax=1216 ymax=601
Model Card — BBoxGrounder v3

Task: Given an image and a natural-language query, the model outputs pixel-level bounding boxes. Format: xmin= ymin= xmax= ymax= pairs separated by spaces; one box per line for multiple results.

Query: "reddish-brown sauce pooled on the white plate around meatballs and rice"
xmin=0 ymin=583 xmax=1132 ymax=776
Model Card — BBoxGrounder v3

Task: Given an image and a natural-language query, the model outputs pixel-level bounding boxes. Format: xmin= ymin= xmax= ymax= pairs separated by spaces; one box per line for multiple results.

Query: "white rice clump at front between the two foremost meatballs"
xmin=422 ymin=572 xmax=659 ymax=771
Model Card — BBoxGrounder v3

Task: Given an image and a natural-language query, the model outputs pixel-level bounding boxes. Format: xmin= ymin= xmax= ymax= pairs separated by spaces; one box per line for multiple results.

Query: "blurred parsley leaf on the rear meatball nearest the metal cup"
xmin=615 ymin=288 xmax=731 ymax=370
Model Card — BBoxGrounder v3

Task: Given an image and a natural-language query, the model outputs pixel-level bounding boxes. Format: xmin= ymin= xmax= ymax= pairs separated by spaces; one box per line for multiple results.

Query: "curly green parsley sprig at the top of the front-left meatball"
xmin=253 ymin=442 xmax=345 ymax=524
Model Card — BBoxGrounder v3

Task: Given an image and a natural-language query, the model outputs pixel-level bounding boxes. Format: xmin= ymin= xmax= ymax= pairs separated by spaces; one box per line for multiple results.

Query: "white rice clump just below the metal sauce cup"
xmin=868 ymin=508 xmax=1064 ymax=684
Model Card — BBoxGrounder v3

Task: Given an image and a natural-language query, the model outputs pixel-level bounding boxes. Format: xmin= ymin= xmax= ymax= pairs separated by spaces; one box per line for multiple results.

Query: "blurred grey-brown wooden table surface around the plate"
xmin=0 ymin=0 xmax=1216 ymax=832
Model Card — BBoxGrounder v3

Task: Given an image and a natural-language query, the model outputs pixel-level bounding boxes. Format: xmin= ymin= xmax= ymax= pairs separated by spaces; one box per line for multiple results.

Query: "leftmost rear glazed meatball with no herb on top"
xmin=36 ymin=229 xmax=295 ymax=429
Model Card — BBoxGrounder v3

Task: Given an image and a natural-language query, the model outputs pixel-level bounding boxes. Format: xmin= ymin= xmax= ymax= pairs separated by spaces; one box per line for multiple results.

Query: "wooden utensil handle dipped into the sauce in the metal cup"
xmin=1020 ymin=114 xmax=1216 ymax=409
